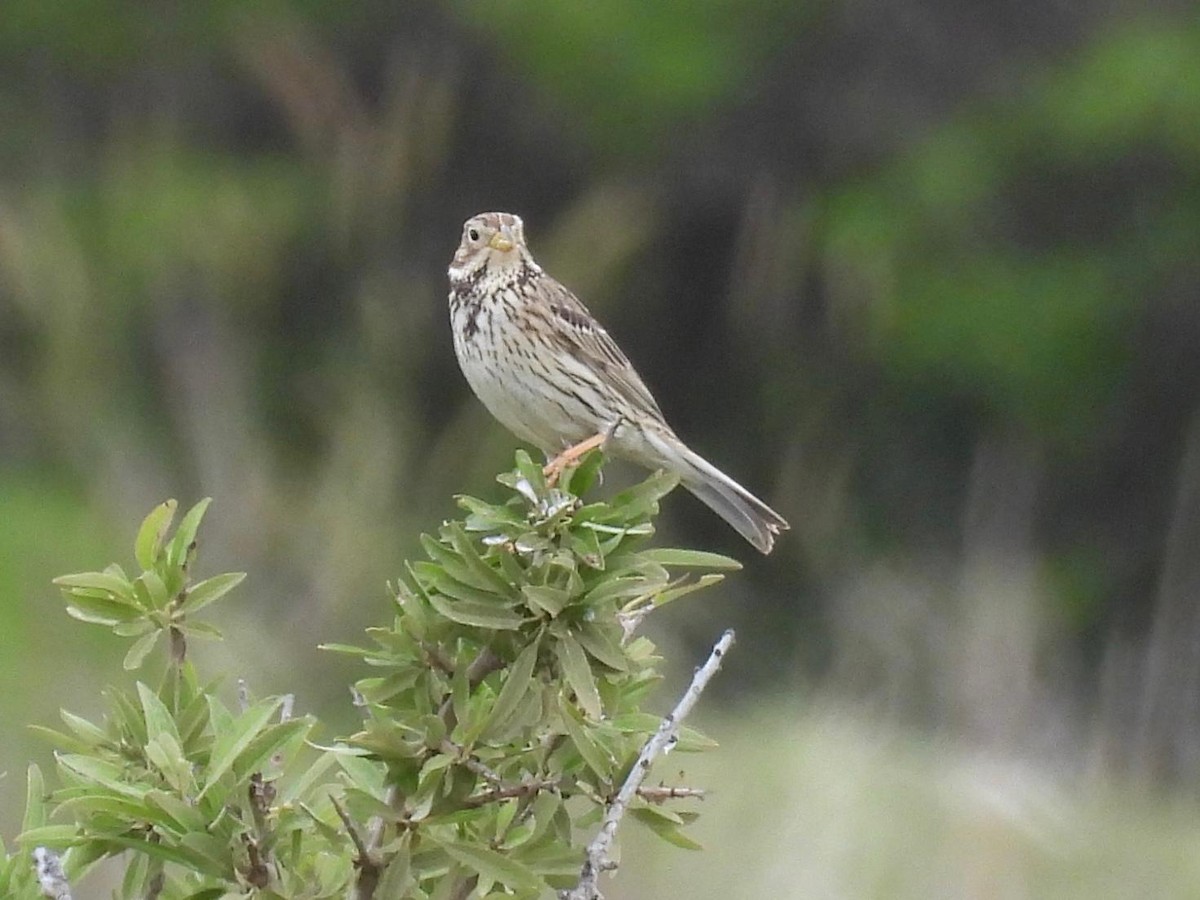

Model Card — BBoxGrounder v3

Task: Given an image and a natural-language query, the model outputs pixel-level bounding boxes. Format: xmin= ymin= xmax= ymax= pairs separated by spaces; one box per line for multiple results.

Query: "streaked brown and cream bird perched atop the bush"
xmin=450 ymin=212 xmax=787 ymax=553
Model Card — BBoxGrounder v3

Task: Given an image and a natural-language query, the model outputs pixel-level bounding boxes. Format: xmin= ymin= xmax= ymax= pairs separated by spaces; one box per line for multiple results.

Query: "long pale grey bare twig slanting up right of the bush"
xmin=559 ymin=629 xmax=733 ymax=900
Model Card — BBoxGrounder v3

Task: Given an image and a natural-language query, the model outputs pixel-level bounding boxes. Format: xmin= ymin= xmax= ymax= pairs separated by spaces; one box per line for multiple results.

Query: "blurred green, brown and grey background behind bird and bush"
xmin=0 ymin=0 xmax=1200 ymax=900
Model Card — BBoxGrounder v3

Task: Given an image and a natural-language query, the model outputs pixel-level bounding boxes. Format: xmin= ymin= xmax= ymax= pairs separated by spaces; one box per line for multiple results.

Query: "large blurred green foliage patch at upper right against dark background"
xmin=822 ymin=25 xmax=1200 ymax=442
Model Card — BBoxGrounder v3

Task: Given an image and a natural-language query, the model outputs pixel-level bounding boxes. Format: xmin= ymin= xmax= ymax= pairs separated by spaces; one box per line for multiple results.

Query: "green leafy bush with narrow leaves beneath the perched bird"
xmin=0 ymin=452 xmax=738 ymax=900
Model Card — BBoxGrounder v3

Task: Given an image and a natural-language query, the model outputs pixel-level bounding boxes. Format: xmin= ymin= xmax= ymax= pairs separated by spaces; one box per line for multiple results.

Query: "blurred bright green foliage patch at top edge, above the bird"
xmin=451 ymin=0 xmax=824 ymax=155
